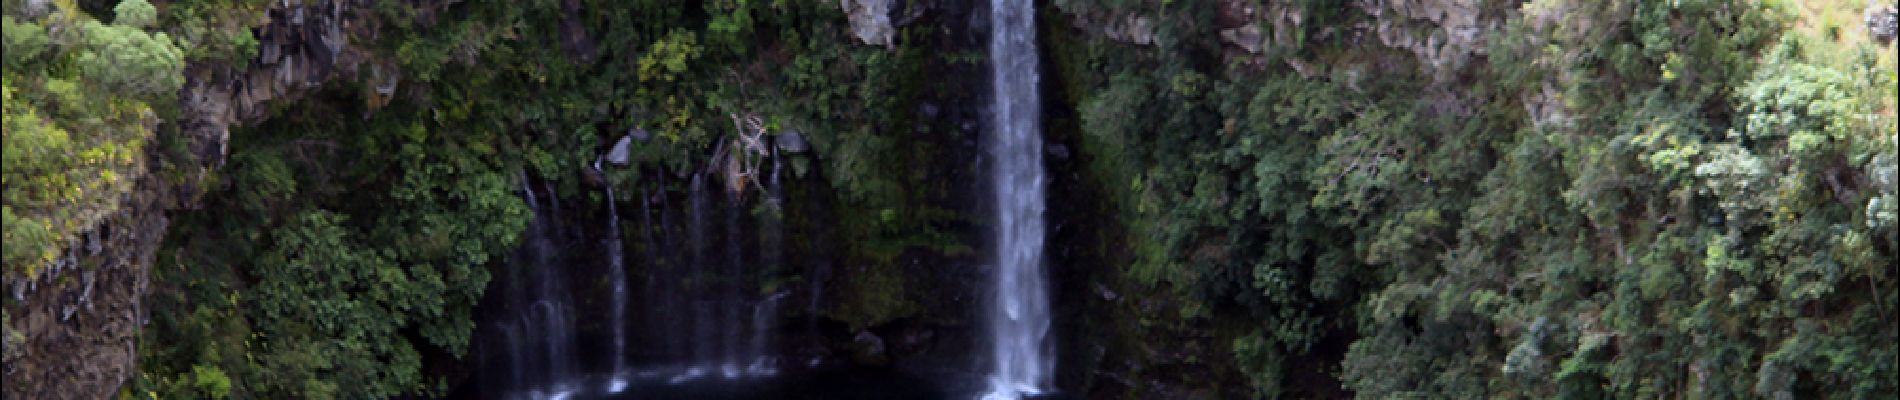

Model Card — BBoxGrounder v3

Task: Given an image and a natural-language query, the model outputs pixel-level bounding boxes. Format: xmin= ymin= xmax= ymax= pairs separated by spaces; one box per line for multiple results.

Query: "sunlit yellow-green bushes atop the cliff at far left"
xmin=0 ymin=0 xmax=184 ymax=279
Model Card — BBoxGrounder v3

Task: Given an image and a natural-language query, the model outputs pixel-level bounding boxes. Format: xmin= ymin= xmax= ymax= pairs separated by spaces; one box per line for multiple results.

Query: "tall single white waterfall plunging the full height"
xmin=984 ymin=0 xmax=1055 ymax=398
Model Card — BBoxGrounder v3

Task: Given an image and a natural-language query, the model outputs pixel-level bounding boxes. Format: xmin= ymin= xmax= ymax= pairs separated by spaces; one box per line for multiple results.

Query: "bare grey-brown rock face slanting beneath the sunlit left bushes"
xmin=0 ymin=0 xmax=395 ymax=398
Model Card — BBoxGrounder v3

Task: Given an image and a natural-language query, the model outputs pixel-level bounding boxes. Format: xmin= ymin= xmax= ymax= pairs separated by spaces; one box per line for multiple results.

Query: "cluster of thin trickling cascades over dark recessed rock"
xmin=477 ymin=151 xmax=790 ymax=398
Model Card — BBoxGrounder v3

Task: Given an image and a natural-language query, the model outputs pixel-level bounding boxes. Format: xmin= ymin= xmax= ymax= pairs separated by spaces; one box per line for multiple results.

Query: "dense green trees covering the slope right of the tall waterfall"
xmin=1062 ymin=0 xmax=1900 ymax=398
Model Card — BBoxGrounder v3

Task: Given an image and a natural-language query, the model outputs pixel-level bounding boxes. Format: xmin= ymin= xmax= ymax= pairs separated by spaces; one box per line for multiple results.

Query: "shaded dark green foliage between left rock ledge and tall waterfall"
xmin=120 ymin=0 xmax=963 ymax=398
